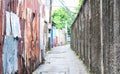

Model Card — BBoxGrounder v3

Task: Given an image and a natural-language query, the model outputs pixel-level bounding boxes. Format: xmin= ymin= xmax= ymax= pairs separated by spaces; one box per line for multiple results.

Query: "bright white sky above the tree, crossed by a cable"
xmin=53 ymin=0 xmax=78 ymax=11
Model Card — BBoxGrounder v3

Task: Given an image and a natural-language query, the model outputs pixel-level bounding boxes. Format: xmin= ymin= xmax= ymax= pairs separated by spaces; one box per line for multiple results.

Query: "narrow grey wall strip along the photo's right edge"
xmin=114 ymin=0 xmax=120 ymax=74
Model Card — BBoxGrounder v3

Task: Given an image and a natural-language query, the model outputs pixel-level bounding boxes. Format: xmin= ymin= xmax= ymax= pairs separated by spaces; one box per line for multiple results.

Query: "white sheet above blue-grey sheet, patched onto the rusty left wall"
xmin=3 ymin=12 xmax=21 ymax=74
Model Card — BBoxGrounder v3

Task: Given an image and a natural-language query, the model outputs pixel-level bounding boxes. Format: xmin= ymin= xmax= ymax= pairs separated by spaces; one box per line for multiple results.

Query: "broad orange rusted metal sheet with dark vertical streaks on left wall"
xmin=25 ymin=9 xmax=40 ymax=73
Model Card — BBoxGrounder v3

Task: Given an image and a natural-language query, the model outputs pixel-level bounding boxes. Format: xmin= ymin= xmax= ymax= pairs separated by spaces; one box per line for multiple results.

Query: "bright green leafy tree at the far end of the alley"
xmin=52 ymin=7 xmax=76 ymax=35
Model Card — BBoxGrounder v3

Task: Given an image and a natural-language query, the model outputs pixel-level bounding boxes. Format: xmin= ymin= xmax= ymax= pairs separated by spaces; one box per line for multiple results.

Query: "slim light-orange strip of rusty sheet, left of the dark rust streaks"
xmin=25 ymin=9 xmax=33 ymax=72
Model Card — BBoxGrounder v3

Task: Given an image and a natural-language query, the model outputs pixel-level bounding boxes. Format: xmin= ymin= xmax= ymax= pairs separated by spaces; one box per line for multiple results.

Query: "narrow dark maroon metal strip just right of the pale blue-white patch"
xmin=18 ymin=18 xmax=26 ymax=74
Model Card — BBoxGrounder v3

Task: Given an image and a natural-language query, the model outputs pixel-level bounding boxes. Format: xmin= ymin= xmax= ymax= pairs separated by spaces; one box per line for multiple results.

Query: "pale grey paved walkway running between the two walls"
xmin=33 ymin=45 xmax=89 ymax=74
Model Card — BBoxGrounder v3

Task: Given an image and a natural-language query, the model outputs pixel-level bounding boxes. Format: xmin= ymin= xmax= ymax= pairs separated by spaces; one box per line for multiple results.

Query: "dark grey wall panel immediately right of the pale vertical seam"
xmin=101 ymin=0 xmax=116 ymax=74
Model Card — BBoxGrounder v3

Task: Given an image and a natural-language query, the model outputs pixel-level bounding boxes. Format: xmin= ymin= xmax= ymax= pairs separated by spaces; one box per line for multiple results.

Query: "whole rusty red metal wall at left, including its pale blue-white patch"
xmin=0 ymin=0 xmax=47 ymax=74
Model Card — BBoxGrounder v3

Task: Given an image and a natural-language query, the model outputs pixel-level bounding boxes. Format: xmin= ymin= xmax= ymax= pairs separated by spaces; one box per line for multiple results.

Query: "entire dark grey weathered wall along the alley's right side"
xmin=71 ymin=0 xmax=120 ymax=74
